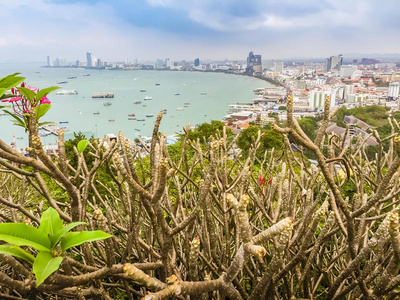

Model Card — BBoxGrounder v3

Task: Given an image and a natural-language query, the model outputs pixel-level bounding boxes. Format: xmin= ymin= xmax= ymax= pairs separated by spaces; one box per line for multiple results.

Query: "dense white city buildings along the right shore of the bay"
xmin=225 ymin=52 xmax=400 ymax=141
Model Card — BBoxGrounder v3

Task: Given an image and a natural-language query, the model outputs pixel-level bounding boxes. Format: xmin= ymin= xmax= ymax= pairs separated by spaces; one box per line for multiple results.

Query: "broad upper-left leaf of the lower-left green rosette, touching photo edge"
xmin=0 ymin=223 xmax=51 ymax=251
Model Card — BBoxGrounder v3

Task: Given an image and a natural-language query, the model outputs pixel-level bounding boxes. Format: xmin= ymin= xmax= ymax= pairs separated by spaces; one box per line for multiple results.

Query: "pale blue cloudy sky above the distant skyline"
xmin=0 ymin=0 xmax=400 ymax=62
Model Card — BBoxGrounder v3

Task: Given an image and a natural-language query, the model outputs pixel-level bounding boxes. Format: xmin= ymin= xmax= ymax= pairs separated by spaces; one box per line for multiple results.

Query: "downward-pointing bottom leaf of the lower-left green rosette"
xmin=32 ymin=251 xmax=62 ymax=286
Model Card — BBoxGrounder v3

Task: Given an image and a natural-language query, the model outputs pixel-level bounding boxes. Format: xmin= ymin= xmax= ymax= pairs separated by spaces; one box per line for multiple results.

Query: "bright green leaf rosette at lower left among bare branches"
xmin=0 ymin=207 xmax=111 ymax=285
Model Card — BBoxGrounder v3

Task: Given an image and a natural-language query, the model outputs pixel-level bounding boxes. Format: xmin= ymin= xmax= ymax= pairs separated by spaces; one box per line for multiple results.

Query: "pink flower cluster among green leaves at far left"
xmin=1 ymin=82 xmax=51 ymax=116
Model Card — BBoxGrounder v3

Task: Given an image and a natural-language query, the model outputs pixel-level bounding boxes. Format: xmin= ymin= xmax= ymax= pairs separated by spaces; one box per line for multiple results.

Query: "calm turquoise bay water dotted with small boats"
xmin=0 ymin=64 xmax=268 ymax=148
